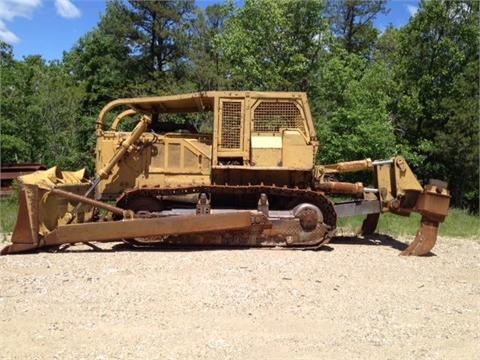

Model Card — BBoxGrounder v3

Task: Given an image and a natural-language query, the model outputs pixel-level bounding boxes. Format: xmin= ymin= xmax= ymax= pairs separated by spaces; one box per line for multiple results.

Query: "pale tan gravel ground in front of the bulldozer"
xmin=0 ymin=236 xmax=480 ymax=359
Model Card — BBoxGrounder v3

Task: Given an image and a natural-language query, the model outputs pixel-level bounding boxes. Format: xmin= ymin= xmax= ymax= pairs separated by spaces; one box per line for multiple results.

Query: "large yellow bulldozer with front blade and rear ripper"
xmin=2 ymin=91 xmax=450 ymax=255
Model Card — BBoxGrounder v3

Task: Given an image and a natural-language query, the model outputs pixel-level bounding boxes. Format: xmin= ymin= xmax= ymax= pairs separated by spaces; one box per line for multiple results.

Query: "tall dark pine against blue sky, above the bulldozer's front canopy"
xmin=116 ymin=0 xmax=195 ymax=96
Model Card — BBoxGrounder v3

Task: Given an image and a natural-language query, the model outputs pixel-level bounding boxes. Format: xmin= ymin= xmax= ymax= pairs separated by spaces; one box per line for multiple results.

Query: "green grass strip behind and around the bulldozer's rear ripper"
xmin=338 ymin=208 xmax=480 ymax=239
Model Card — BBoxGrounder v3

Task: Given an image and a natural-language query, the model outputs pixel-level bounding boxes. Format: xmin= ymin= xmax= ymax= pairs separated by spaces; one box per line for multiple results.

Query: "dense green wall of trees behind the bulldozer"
xmin=0 ymin=0 xmax=480 ymax=211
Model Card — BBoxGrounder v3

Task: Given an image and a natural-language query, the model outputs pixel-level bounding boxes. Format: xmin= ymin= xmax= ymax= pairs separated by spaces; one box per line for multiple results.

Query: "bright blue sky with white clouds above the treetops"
xmin=0 ymin=0 xmax=419 ymax=61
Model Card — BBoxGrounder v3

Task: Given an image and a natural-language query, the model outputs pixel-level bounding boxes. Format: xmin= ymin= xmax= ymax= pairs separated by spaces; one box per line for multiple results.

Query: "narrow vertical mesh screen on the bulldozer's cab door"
xmin=221 ymin=101 xmax=242 ymax=149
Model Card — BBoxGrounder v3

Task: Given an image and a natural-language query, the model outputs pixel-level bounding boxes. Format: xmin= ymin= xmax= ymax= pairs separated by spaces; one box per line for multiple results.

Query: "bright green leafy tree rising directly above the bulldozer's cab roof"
xmin=217 ymin=0 xmax=328 ymax=91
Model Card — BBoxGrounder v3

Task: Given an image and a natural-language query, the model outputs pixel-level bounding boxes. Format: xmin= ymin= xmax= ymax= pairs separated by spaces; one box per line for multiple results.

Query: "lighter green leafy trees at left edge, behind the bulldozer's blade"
xmin=0 ymin=52 xmax=85 ymax=167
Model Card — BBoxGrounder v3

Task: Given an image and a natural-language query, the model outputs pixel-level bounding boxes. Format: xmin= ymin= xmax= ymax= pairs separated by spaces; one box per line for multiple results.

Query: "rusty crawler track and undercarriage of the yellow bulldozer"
xmin=117 ymin=185 xmax=337 ymax=247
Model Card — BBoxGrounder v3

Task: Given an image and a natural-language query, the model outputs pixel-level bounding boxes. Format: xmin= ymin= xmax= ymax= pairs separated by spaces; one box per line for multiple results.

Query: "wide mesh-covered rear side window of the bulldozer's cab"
xmin=253 ymin=101 xmax=305 ymax=133
